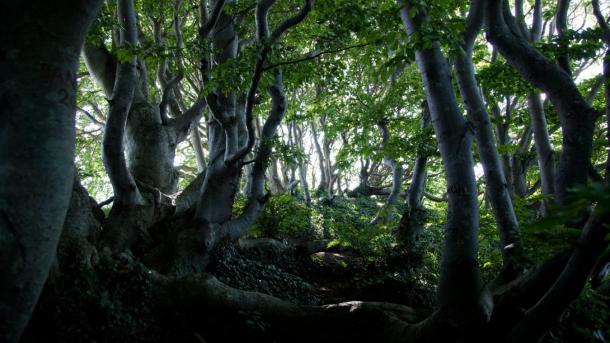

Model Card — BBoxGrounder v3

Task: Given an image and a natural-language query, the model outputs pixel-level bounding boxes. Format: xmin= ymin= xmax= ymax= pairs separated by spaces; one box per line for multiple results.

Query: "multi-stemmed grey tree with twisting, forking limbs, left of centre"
xmin=169 ymin=0 xmax=313 ymax=275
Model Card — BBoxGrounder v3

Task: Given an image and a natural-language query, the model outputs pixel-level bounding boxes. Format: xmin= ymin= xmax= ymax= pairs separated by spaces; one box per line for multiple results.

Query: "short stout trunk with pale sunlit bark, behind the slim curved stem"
xmin=84 ymin=27 xmax=206 ymax=194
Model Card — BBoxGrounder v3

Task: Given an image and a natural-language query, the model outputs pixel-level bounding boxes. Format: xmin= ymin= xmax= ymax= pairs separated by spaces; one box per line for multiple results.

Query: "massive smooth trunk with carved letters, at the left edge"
xmin=0 ymin=0 xmax=102 ymax=343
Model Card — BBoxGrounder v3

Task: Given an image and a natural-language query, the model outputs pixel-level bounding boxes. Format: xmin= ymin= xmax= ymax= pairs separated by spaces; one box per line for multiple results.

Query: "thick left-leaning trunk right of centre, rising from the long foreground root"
xmin=398 ymin=0 xmax=491 ymax=337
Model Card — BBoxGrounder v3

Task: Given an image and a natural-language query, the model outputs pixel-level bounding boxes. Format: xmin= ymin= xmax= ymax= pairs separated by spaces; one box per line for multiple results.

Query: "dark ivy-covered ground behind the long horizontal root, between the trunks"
xmin=211 ymin=241 xmax=434 ymax=308
